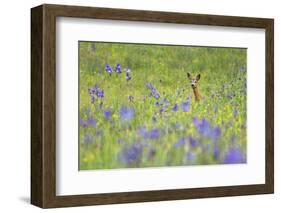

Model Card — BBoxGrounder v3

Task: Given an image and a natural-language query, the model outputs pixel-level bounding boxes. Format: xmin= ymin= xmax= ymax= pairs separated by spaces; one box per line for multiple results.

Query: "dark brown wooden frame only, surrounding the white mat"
xmin=31 ymin=5 xmax=274 ymax=208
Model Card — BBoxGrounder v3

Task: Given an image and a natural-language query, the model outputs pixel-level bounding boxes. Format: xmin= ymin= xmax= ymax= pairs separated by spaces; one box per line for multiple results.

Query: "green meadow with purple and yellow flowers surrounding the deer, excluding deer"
xmin=79 ymin=41 xmax=247 ymax=170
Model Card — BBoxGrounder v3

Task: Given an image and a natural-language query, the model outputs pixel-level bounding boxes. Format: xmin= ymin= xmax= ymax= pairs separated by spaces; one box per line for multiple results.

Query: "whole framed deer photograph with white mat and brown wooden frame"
xmin=31 ymin=5 xmax=274 ymax=208
